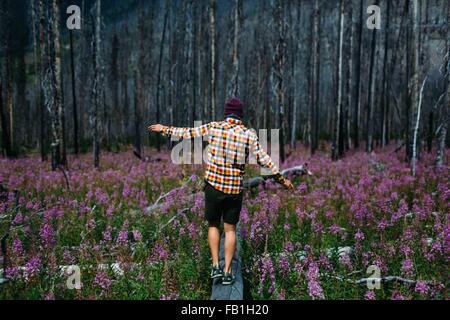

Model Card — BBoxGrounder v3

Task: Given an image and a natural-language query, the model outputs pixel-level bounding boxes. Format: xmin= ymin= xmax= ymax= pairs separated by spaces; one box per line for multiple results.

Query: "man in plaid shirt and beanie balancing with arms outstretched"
xmin=148 ymin=98 xmax=293 ymax=285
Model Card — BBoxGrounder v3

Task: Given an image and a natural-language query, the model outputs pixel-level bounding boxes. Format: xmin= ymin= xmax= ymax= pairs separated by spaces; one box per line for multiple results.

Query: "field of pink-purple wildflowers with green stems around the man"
xmin=0 ymin=148 xmax=450 ymax=299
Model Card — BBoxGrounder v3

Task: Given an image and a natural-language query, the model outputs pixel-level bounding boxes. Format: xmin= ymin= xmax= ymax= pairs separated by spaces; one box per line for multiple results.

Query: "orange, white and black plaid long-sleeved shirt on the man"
xmin=163 ymin=117 xmax=284 ymax=194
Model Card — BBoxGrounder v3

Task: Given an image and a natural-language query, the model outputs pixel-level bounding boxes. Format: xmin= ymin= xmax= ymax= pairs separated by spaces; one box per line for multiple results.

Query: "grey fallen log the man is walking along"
xmin=211 ymin=225 xmax=244 ymax=300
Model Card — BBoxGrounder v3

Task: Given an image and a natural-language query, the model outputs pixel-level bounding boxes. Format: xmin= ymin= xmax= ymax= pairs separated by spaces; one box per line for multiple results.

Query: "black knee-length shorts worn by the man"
xmin=205 ymin=182 xmax=243 ymax=227
